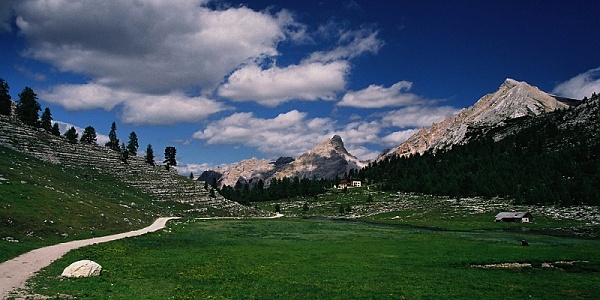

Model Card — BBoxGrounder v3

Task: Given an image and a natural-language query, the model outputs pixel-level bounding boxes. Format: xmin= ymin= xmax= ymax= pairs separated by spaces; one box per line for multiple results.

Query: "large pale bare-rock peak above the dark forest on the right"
xmin=377 ymin=78 xmax=571 ymax=161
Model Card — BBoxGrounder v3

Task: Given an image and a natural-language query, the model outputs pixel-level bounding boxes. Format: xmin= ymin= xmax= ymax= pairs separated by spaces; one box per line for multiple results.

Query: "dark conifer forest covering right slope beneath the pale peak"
xmin=359 ymin=94 xmax=600 ymax=205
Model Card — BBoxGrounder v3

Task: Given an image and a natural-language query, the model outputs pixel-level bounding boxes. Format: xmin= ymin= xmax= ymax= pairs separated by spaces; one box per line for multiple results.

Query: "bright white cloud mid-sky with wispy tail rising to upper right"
xmin=218 ymin=25 xmax=383 ymax=107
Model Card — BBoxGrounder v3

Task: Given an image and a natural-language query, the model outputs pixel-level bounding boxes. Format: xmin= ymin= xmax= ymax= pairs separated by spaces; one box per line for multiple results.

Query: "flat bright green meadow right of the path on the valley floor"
xmin=22 ymin=218 xmax=600 ymax=299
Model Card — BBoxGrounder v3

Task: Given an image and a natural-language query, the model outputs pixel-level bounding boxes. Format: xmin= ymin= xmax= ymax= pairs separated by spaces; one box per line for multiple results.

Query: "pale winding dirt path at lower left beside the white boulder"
xmin=0 ymin=217 xmax=176 ymax=299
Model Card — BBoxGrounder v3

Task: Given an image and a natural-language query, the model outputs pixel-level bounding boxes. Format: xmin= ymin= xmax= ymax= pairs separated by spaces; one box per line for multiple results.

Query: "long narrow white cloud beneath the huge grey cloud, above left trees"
xmin=40 ymin=84 xmax=228 ymax=125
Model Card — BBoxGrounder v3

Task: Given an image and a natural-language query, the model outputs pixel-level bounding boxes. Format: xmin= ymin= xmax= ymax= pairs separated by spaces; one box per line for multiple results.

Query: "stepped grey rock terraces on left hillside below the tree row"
xmin=0 ymin=116 xmax=266 ymax=216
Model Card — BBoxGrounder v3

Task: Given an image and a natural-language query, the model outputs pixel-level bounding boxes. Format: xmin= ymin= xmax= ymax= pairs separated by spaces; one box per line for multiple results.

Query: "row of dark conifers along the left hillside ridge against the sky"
xmin=0 ymin=78 xmax=177 ymax=169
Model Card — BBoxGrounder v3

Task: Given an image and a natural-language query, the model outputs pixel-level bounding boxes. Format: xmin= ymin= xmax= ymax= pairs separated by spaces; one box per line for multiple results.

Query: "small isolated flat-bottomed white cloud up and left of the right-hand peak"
xmin=338 ymin=81 xmax=425 ymax=108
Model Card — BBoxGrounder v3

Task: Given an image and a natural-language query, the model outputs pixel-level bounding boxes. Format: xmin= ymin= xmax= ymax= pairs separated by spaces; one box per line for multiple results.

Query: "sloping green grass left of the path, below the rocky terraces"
xmin=0 ymin=147 xmax=162 ymax=261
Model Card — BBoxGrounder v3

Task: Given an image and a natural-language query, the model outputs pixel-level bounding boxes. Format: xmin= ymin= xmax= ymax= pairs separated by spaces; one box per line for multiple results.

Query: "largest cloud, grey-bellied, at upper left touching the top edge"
xmin=15 ymin=0 xmax=292 ymax=93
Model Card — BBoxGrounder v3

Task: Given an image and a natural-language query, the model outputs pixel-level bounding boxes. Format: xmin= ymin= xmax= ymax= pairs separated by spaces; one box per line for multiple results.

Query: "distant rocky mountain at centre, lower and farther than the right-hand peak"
xmin=199 ymin=135 xmax=367 ymax=186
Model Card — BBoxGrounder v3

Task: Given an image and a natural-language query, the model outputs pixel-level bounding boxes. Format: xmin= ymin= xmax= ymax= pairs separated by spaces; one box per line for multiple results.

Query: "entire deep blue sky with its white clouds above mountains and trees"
xmin=0 ymin=0 xmax=600 ymax=174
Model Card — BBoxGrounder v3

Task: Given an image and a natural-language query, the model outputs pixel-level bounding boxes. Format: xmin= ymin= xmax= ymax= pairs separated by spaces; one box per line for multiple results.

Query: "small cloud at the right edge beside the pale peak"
xmin=552 ymin=67 xmax=600 ymax=99
